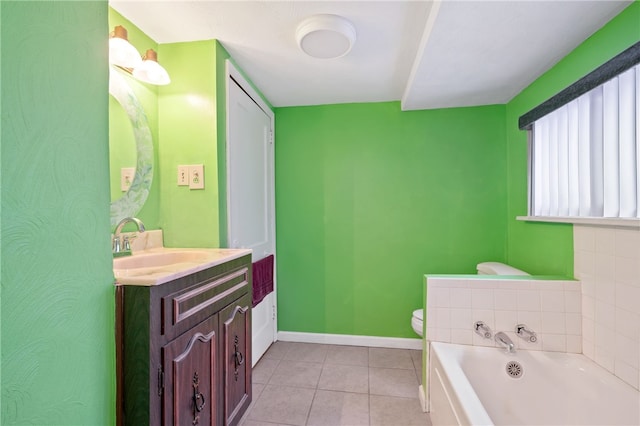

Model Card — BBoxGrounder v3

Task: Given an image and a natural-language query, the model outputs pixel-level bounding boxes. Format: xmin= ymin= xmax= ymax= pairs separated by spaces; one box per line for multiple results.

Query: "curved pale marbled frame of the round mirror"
xmin=109 ymin=66 xmax=153 ymax=227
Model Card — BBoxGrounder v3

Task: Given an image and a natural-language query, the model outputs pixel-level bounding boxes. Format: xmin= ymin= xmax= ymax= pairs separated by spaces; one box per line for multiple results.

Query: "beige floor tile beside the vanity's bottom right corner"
xmin=246 ymin=385 xmax=315 ymax=426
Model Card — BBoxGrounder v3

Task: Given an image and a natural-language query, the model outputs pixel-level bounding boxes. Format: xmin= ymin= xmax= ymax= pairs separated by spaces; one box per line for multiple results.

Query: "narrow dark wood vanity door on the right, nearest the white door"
xmin=220 ymin=296 xmax=251 ymax=425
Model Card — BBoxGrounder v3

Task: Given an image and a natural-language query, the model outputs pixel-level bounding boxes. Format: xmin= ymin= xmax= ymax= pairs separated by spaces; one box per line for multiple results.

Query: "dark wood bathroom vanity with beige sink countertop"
xmin=114 ymin=249 xmax=252 ymax=426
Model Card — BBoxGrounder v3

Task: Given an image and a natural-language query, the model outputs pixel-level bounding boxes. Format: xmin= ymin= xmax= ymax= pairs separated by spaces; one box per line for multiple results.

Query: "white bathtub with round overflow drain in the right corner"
xmin=429 ymin=342 xmax=640 ymax=426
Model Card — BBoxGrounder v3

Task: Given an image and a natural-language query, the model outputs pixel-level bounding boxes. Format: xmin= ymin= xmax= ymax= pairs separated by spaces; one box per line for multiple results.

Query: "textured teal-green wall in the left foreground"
xmin=0 ymin=1 xmax=115 ymax=425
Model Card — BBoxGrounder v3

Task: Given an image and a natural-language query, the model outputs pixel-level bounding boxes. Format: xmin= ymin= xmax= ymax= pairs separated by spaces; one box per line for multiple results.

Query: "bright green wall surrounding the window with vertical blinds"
xmin=506 ymin=0 xmax=640 ymax=276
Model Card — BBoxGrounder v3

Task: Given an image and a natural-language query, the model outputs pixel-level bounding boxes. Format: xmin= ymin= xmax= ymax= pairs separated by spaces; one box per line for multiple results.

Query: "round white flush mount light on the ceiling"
xmin=296 ymin=15 xmax=356 ymax=59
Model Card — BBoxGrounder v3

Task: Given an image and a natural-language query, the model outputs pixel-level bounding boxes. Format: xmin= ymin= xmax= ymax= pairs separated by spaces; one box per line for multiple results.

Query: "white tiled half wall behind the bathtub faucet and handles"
xmin=426 ymin=275 xmax=582 ymax=353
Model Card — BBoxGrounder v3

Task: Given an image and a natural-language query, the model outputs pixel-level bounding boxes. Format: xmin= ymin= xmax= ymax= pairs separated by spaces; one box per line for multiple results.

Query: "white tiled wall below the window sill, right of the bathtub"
xmin=573 ymin=225 xmax=640 ymax=389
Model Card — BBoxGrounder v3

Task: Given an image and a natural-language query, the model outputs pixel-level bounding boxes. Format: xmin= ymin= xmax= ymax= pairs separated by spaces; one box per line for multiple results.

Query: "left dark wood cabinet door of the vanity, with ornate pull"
xmin=162 ymin=315 xmax=222 ymax=426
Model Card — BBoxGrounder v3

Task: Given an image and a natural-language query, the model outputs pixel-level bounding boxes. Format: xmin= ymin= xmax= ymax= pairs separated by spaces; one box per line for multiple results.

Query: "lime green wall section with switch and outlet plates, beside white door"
xmin=158 ymin=40 xmax=220 ymax=247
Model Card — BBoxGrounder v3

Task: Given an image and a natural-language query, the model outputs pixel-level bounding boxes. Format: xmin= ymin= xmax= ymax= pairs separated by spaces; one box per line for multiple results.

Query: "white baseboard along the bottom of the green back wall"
xmin=278 ymin=331 xmax=422 ymax=350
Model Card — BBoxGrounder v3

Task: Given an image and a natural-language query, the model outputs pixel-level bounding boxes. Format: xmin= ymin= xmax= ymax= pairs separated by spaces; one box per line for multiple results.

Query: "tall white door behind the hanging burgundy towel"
xmin=227 ymin=64 xmax=277 ymax=365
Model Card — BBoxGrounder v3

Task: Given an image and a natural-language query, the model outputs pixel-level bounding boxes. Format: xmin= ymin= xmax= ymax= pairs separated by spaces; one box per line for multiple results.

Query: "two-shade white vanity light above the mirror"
xmin=109 ymin=25 xmax=171 ymax=86
